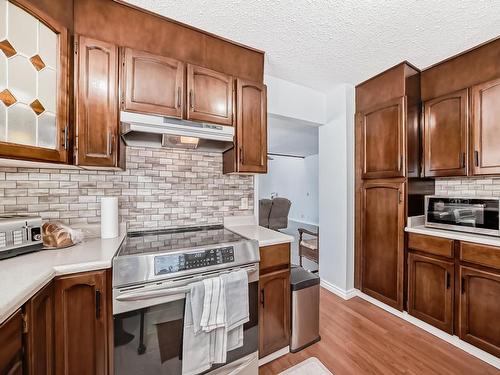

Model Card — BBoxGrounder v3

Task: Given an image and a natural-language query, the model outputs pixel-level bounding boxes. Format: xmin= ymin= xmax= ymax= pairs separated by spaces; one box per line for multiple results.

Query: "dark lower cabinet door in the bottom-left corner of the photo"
xmin=0 ymin=310 xmax=23 ymax=374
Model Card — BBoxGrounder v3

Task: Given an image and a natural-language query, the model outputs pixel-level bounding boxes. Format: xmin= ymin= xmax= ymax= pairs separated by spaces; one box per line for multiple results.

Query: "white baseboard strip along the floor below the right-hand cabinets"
xmin=356 ymin=290 xmax=500 ymax=369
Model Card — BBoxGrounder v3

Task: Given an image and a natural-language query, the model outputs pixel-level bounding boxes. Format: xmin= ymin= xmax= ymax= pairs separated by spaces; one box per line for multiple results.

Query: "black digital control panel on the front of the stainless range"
xmin=155 ymin=246 xmax=234 ymax=275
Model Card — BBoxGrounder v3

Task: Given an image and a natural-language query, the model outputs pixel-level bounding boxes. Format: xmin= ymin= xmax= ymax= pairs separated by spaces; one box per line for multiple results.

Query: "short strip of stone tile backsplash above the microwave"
xmin=436 ymin=177 xmax=500 ymax=197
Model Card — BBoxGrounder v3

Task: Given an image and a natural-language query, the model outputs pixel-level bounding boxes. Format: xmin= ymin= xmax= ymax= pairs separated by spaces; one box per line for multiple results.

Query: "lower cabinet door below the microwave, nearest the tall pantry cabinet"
xmin=408 ymin=252 xmax=454 ymax=334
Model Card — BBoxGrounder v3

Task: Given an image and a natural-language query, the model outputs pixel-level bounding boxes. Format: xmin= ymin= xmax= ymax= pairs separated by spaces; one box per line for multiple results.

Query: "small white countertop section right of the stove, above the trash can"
xmin=224 ymin=216 xmax=295 ymax=247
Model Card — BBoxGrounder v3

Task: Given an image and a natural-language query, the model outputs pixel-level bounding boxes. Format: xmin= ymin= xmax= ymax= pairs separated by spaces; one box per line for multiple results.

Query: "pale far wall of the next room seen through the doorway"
xmin=258 ymin=155 xmax=318 ymax=224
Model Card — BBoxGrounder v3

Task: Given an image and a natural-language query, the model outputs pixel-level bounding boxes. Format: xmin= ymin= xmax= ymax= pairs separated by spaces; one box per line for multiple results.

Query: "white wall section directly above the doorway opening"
xmin=264 ymin=75 xmax=326 ymax=124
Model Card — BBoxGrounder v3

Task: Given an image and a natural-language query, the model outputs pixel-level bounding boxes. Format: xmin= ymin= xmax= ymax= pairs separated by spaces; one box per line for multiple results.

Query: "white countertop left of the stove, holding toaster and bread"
xmin=0 ymin=224 xmax=127 ymax=323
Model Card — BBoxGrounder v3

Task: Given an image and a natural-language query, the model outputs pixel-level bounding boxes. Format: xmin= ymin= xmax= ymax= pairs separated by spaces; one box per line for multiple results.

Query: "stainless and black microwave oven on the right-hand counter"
xmin=425 ymin=195 xmax=500 ymax=236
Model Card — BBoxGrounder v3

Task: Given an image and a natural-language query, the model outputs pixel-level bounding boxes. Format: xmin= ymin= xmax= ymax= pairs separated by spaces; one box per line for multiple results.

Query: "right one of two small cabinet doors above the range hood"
xmin=187 ymin=64 xmax=233 ymax=125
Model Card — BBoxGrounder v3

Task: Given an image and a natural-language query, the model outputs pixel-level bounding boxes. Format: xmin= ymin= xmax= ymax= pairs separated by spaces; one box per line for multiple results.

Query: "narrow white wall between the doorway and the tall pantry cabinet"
xmin=319 ymin=84 xmax=354 ymax=292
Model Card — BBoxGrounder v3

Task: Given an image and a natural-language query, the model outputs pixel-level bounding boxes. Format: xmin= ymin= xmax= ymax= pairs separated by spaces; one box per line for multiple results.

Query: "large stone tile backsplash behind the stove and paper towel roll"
xmin=0 ymin=147 xmax=254 ymax=230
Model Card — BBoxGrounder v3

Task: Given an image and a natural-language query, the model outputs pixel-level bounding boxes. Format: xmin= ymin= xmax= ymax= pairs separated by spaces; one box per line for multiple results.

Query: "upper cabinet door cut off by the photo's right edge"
xmin=472 ymin=79 xmax=500 ymax=175
